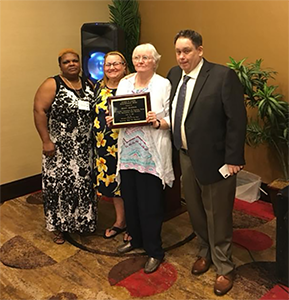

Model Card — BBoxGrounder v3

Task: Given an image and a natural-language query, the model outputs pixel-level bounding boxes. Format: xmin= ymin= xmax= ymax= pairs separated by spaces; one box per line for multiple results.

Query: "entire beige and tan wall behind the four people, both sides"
xmin=0 ymin=0 xmax=289 ymax=185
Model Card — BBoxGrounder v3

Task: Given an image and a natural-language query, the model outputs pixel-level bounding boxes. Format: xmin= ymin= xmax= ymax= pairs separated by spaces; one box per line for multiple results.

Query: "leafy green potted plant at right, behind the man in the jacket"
xmin=227 ymin=57 xmax=289 ymax=211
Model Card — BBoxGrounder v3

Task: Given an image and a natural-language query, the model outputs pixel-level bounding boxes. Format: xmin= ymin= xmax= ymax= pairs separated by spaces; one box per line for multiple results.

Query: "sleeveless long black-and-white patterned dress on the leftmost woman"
xmin=42 ymin=76 xmax=97 ymax=232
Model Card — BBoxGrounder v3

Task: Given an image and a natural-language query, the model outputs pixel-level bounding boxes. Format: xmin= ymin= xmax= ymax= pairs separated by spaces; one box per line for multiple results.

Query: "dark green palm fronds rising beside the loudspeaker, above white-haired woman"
xmin=108 ymin=0 xmax=140 ymax=72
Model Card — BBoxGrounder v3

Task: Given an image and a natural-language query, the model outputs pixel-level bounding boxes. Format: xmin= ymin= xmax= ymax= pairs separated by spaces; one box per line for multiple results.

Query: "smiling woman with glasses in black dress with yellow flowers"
xmin=93 ymin=51 xmax=128 ymax=239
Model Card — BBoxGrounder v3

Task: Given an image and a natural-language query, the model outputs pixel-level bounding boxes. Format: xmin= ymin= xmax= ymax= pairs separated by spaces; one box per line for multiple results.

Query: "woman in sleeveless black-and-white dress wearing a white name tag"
xmin=34 ymin=49 xmax=97 ymax=244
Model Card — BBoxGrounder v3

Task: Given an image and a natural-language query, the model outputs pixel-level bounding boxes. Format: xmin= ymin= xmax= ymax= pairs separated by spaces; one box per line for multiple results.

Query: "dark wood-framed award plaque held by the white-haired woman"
xmin=108 ymin=93 xmax=151 ymax=128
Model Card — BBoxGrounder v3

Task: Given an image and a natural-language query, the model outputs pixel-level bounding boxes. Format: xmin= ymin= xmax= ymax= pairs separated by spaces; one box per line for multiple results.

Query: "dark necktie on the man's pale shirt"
xmin=173 ymin=75 xmax=191 ymax=150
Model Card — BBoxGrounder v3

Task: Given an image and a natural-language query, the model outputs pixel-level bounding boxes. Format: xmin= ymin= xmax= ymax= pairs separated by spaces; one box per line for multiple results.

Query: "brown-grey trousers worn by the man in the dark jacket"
xmin=180 ymin=150 xmax=236 ymax=275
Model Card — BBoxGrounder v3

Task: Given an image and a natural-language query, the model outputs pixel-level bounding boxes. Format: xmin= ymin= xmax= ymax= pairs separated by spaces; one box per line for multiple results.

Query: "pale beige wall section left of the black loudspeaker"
xmin=0 ymin=0 xmax=111 ymax=185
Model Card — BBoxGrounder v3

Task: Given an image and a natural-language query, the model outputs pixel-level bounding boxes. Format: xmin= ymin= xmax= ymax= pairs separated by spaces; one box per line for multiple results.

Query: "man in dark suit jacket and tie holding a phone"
xmin=167 ymin=30 xmax=247 ymax=296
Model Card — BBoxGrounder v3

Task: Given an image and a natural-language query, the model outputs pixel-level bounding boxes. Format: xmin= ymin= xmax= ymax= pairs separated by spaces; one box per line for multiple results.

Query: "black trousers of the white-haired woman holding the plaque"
xmin=120 ymin=170 xmax=164 ymax=259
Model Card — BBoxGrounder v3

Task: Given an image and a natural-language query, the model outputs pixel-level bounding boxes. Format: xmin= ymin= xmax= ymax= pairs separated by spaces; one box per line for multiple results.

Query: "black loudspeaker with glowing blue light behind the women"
xmin=81 ymin=23 xmax=125 ymax=82
